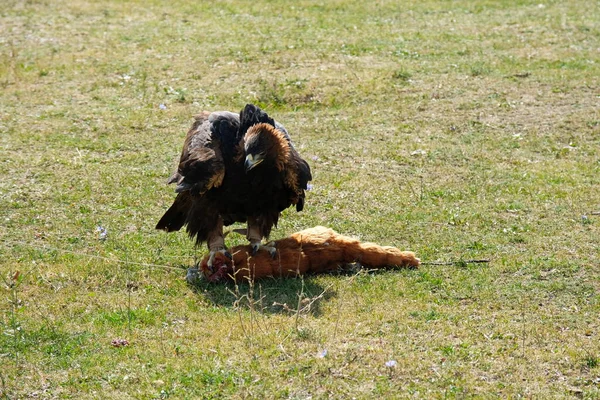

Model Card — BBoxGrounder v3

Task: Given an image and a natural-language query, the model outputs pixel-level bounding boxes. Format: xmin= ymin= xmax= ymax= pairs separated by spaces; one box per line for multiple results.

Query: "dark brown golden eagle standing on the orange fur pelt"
xmin=156 ymin=104 xmax=312 ymax=265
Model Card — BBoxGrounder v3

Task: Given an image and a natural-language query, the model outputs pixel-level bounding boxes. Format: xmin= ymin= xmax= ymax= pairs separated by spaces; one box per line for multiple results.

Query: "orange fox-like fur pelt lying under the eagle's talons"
xmin=200 ymin=226 xmax=419 ymax=282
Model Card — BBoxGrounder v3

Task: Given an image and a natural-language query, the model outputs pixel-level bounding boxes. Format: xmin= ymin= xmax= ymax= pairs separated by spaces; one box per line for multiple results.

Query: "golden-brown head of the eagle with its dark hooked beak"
xmin=244 ymin=123 xmax=290 ymax=172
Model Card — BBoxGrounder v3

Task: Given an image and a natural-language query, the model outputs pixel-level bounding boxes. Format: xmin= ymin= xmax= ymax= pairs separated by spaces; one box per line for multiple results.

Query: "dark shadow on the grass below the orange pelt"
xmin=189 ymin=276 xmax=337 ymax=316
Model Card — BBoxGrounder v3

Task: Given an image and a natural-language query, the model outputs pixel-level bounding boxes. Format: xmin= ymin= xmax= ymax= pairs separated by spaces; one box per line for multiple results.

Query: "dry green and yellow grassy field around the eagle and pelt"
xmin=0 ymin=0 xmax=600 ymax=399
